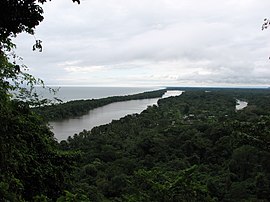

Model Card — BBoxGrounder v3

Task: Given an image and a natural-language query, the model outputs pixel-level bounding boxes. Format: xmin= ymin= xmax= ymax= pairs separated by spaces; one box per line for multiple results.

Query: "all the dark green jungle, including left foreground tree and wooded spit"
xmin=0 ymin=0 xmax=270 ymax=202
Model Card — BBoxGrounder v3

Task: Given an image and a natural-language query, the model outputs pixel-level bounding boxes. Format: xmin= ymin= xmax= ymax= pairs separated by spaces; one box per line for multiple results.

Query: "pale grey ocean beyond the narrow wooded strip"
xmin=36 ymin=86 xmax=160 ymax=102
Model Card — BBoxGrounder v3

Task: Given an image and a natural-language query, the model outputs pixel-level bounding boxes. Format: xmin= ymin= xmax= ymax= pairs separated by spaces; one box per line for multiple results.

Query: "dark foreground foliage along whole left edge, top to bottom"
xmin=0 ymin=0 xmax=82 ymax=201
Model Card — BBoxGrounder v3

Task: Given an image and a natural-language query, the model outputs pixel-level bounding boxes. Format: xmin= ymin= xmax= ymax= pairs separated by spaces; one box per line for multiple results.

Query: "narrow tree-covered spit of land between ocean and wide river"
xmin=33 ymin=89 xmax=167 ymax=121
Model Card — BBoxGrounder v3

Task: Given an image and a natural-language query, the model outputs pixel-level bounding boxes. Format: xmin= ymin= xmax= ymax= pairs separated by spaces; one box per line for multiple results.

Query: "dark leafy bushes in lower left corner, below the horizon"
xmin=0 ymin=94 xmax=79 ymax=201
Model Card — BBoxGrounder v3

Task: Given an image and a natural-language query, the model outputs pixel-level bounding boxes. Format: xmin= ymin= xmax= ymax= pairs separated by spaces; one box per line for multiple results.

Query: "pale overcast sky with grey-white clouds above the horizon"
xmin=14 ymin=0 xmax=270 ymax=87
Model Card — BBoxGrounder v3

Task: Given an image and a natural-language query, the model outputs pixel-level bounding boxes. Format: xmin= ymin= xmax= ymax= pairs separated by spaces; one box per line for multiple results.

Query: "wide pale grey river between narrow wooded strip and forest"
xmin=49 ymin=91 xmax=182 ymax=141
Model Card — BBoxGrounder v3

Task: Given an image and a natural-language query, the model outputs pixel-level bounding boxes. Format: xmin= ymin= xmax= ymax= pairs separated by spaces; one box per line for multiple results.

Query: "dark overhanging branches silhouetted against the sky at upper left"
xmin=0 ymin=0 xmax=80 ymax=102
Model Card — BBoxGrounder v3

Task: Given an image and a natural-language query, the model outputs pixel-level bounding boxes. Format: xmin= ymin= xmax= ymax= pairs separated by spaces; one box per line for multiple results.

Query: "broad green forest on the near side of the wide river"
xmin=2 ymin=88 xmax=270 ymax=202
